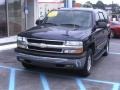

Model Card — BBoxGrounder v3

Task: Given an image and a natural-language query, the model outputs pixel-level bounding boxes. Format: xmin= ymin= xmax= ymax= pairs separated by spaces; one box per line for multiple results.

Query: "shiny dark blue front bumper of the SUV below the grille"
xmin=17 ymin=48 xmax=86 ymax=69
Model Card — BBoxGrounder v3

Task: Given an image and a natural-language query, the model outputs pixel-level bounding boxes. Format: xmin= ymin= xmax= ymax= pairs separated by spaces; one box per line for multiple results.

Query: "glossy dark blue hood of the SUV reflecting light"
xmin=19 ymin=26 xmax=91 ymax=41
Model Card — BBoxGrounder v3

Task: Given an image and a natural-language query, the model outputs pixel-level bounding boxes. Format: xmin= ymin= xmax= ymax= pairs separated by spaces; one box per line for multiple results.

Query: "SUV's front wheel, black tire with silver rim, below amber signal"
xmin=81 ymin=49 xmax=93 ymax=77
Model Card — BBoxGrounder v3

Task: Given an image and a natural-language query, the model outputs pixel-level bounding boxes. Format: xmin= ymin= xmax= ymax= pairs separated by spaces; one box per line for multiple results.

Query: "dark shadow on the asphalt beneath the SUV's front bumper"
xmin=26 ymin=66 xmax=82 ymax=77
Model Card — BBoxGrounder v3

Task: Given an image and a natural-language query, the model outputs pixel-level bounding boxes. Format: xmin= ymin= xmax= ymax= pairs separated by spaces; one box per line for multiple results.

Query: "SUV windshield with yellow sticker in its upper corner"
xmin=46 ymin=10 xmax=92 ymax=27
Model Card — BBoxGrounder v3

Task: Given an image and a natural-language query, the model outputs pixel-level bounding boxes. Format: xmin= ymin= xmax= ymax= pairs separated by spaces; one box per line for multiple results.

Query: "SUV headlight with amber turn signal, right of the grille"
xmin=64 ymin=41 xmax=83 ymax=54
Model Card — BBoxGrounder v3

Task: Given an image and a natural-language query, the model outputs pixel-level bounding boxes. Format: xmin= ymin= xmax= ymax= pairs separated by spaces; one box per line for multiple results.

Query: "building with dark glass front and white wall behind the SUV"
xmin=0 ymin=0 xmax=64 ymax=39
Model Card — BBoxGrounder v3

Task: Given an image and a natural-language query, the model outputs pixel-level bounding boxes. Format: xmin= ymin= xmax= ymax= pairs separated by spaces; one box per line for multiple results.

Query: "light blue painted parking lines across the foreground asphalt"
xmin=0 ymin=66 xmax=120 ymax=90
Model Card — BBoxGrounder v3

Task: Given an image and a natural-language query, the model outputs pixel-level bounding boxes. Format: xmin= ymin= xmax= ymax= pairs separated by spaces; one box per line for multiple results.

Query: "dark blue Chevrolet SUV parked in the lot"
xmin=15 ymin=8 xmax=110 ymax=76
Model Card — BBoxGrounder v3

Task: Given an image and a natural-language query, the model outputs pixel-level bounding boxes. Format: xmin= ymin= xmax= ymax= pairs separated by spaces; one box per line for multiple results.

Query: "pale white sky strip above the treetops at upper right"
xmin=76 ymin=0 xmax=120 ymax=5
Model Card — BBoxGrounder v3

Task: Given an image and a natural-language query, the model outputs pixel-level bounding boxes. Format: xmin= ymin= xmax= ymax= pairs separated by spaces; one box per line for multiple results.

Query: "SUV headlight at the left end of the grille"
xmin=17 ymin=36 xmax=27 ymax=48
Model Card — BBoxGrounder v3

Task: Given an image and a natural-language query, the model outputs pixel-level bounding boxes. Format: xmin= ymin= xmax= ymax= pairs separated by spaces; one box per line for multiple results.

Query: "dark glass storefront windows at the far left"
xmin=0 ymin=0 xmax=24 ymax=38
